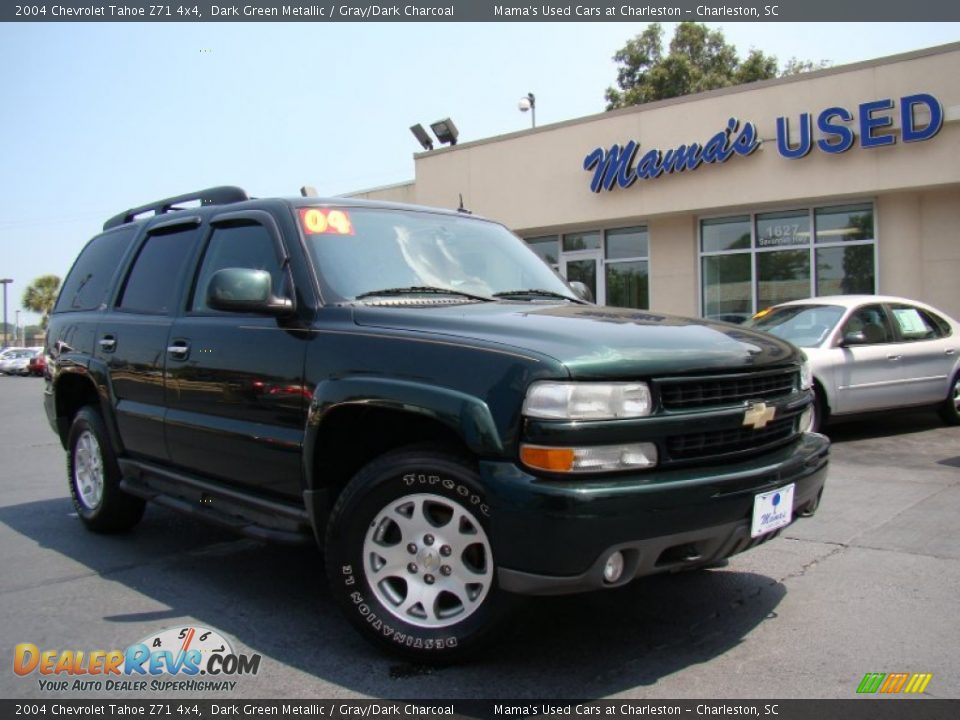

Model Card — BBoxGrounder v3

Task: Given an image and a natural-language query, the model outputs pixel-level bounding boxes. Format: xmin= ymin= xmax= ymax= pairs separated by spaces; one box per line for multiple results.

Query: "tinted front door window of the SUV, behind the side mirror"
xmin=191 ymin=225 xmax=280 ymax=312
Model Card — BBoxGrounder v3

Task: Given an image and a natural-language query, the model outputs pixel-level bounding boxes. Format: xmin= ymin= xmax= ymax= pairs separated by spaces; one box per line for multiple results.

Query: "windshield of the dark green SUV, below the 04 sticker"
xmin=306 ymin=208 xmax=576 ymax=300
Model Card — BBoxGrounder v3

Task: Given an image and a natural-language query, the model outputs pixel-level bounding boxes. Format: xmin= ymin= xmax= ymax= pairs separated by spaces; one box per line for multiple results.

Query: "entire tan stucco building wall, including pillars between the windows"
xmin=358 ymin=43 xmax=960 ymax=317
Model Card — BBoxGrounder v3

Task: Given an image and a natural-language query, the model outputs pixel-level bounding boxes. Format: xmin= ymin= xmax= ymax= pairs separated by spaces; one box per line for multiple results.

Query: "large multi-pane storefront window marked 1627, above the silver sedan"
xmin=700 ymin=203 xmax=876 ymax=319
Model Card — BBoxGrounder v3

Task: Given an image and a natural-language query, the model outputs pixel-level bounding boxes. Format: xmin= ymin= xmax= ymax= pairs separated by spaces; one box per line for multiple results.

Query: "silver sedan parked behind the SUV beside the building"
xmin=747 ymin=295 xmax=960 ymax=429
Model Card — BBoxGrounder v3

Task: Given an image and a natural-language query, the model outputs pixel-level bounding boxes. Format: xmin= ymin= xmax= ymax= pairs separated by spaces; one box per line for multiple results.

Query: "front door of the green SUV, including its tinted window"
xmin=165 ymin=210 xmax=312 ymax=497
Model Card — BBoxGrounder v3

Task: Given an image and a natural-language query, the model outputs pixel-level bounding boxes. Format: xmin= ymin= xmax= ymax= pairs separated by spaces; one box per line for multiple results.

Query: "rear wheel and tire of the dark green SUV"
xmin=67 ymin=407 xmax=145 ymax=533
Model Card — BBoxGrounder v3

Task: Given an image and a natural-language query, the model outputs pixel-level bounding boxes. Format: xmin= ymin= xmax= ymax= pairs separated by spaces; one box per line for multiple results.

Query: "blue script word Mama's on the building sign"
xmin=583 ymin=118 xmax=760 ymax=192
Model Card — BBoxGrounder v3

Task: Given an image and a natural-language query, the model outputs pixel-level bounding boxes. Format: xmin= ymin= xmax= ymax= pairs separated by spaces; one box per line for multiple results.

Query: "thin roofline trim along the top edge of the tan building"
xmin=413 ymin=42 xmax=960 ymax=160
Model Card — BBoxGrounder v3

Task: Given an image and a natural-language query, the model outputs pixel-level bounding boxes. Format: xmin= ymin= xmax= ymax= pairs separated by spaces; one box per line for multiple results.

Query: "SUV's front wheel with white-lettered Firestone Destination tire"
xmin=326 ymin=450 xmax=511 ymax=664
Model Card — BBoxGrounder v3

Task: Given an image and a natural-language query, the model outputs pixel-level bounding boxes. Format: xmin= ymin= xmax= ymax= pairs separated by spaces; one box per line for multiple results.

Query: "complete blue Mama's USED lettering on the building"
xmin=583 ymin=93 xmax=943 ymax=193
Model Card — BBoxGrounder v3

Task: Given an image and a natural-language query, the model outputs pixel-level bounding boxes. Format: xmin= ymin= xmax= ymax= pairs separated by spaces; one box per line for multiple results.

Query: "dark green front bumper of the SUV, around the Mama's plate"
xmin=480 ymin=434 xmax=830 ymax=595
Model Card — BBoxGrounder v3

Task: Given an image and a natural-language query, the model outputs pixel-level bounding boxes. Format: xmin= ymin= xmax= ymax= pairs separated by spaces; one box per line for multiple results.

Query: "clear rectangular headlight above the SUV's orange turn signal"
xmin=523 ymin=381 xmax=653 ymax=420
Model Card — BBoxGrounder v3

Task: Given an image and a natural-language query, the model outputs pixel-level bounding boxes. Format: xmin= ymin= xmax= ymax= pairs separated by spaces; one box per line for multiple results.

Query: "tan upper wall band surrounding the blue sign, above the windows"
xmin=406 ymin=46 xmax=960 ymax=232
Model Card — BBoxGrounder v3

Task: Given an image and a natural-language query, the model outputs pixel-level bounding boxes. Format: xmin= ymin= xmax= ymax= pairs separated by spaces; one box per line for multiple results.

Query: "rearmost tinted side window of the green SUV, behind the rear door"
xmin=54 ymin=227 xmax=136 ymax=312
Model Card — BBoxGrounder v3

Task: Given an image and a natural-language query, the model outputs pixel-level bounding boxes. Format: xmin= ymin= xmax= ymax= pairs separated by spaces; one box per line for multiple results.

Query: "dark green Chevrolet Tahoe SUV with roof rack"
xmin=45 ymin=187 xmax=828 ymax=661
